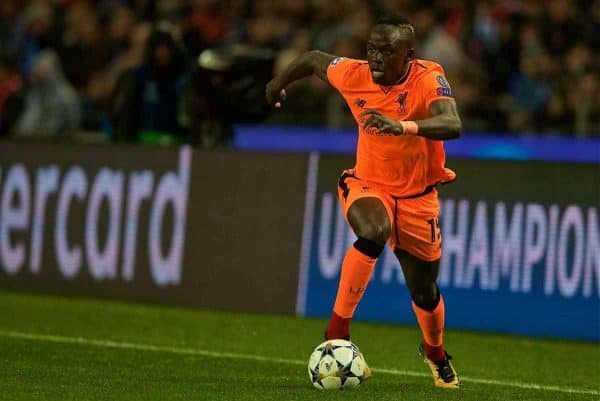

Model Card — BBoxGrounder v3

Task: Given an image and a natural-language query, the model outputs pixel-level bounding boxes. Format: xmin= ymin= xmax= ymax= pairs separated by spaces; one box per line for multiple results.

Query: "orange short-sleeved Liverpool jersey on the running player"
xmin=327 ymin=57 xmax=456 ymax=197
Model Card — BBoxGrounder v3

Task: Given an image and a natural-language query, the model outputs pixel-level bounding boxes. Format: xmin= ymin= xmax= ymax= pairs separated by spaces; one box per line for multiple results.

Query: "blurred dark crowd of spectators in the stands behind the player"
xmin=0 ymin=0 xmax=600 ymax=147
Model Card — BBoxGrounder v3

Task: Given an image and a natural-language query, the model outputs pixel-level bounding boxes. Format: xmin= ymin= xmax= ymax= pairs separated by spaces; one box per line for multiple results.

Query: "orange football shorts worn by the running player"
xmin=338 ymin=170 xmax=442 ymax=261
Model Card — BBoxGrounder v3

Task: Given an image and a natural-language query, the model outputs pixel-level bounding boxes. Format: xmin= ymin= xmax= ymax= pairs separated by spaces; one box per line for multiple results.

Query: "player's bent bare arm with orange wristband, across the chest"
xmin=363 ymin=98 xmax=462 ymax=141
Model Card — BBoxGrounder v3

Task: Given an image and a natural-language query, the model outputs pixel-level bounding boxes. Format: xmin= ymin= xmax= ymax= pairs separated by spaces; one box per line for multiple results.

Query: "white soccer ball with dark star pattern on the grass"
xmin=308 ymin=340 xmax=366 ymax=390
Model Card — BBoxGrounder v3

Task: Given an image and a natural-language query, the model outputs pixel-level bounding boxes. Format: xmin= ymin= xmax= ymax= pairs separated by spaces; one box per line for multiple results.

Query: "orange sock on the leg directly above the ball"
xmin=326 ymin=246 xmax=377 ymax=338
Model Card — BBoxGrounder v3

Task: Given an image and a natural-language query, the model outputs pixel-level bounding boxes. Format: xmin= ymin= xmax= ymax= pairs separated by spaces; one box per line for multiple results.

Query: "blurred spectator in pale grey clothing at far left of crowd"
xmin=15 ymin=50 xmax=80 ymax=135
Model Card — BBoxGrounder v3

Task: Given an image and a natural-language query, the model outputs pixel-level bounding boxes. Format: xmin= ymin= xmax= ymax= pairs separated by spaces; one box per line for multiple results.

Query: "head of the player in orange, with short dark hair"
xmin=367 ymin=15 xmax=415 ymax=85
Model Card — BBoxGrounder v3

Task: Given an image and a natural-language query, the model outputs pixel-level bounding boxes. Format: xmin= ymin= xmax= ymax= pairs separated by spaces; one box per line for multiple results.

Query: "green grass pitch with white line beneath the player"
xmin=0 ymin=293 xmax=600 ymax=401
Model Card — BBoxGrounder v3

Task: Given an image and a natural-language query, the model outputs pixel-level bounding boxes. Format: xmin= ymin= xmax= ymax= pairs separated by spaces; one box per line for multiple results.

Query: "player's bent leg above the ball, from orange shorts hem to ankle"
xmin=325 ymin=174 xmax=391 ymax=339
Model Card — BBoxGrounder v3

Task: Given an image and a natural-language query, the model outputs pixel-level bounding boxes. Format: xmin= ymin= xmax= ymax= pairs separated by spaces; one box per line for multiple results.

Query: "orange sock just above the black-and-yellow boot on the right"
xmin=413 ymin=294 xmax=445 ymax=361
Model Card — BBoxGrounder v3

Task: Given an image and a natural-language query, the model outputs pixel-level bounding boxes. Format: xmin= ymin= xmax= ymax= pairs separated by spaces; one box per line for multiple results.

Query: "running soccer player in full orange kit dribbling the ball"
xmin=266 ymin=16 xmax=461 ymax=388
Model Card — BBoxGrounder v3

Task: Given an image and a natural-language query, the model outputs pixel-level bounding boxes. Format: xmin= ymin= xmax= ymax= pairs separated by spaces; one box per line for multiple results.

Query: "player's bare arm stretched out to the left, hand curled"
xmin=266 ymin=50 xmax=336 ymax=107
